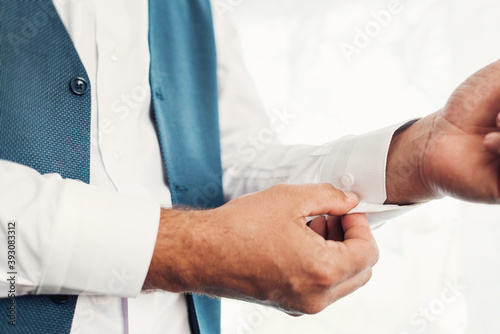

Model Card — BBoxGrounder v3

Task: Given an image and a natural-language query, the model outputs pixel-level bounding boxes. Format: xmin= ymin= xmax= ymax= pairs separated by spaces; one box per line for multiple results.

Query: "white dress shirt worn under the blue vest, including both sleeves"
xmin=0 ymin=0 xmax=406 ymax=334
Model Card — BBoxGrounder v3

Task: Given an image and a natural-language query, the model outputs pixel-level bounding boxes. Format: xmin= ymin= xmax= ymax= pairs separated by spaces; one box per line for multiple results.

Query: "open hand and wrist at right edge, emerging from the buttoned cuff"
xmin=387 ymin=61 xmax=500 ymax=204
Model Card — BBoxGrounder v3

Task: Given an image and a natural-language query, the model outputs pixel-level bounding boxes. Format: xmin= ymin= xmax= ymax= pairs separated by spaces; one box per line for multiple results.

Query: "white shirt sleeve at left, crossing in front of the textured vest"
xmin=0 ymin=160 xmax=160 ymax=298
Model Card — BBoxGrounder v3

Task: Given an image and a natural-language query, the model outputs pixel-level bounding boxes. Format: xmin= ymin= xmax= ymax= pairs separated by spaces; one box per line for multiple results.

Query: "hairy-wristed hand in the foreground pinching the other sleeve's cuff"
xmin=144 ymin=184 xmax=378 ymax=315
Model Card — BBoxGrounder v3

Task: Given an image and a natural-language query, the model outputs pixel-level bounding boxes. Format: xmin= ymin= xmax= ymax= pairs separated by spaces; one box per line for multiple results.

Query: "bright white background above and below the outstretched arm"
xmin=221 ymin=0 xmax=500 ymax=334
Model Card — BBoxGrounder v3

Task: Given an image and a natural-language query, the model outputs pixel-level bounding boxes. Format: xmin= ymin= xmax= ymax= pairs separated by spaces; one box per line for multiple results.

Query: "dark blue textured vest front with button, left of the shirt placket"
xmin=0 ymin=0 xmax=91 ymax=333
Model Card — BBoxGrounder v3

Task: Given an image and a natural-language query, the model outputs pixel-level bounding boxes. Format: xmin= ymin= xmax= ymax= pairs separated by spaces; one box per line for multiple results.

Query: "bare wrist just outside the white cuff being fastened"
xmin=385 ymin=114 xmax=440 ymax=205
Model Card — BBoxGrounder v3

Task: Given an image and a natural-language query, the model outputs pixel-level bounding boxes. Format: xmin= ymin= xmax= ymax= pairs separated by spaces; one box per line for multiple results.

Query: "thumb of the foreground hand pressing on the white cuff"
xmin=294 ymin=183 xmax=359 ymax=217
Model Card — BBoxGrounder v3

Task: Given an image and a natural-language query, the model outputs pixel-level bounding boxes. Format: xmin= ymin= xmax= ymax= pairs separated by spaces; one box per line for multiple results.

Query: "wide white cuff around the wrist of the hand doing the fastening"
xmin=37 ymin=180 xmax=161 ymax=297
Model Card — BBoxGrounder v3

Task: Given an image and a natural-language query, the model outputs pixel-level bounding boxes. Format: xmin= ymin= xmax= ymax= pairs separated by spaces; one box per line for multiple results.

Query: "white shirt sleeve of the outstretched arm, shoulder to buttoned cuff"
xmin=214 ymin=11 xmax=418 ymax=228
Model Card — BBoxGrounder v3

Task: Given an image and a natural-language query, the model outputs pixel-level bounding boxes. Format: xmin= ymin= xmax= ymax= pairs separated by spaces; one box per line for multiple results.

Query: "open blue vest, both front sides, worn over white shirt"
xmin=0 ymin=0 xmax=223 ymax=334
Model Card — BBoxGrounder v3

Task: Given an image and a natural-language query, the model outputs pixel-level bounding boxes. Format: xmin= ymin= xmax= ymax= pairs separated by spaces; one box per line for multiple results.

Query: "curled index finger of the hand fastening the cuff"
xmin=328 ymin=213 xmax=379 ymax=282
